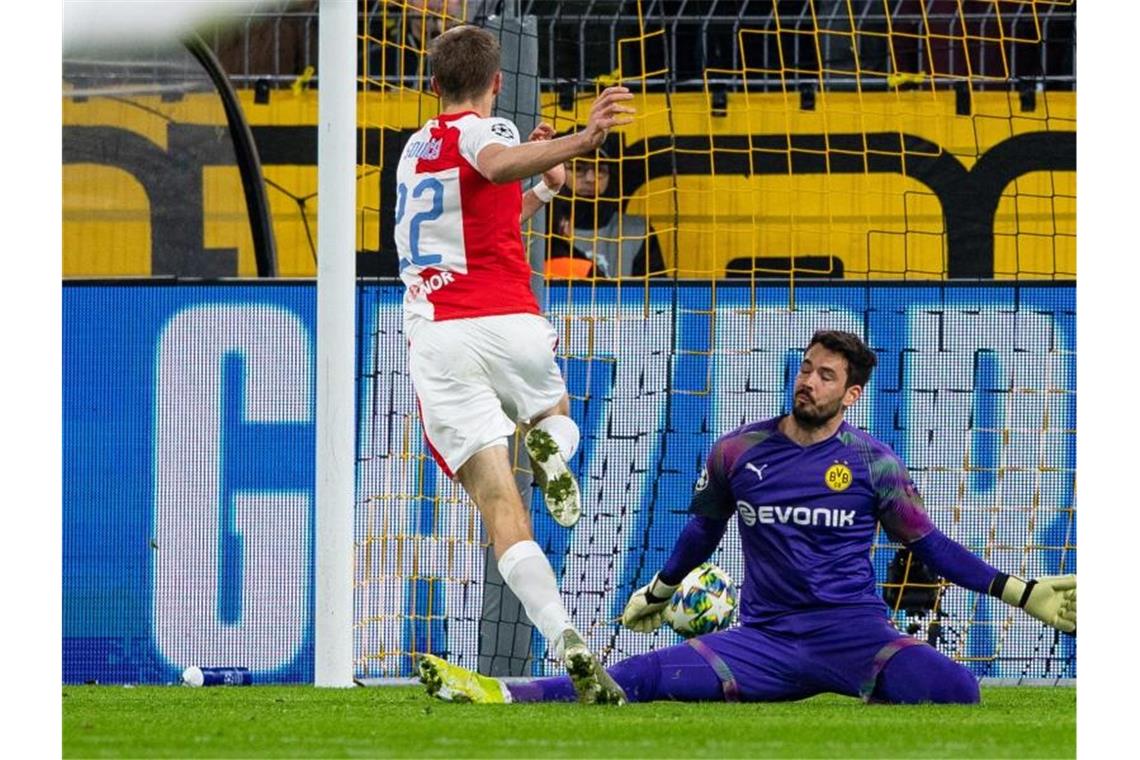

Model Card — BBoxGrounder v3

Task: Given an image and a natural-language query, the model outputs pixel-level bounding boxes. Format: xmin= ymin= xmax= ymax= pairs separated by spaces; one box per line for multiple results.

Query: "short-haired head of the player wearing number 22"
xmin=428 ymin=24 xmax=503 ymax=103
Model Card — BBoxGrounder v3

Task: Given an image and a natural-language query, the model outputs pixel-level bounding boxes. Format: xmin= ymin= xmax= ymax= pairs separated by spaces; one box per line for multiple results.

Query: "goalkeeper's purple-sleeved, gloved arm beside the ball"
xmin=621 ymin=515 xmax=728 ymax=634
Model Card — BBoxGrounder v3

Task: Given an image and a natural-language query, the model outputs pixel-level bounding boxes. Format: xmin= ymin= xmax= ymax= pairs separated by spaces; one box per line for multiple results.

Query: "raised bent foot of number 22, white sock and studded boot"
xmin=526 ymin=395 xmax=581 ymax=528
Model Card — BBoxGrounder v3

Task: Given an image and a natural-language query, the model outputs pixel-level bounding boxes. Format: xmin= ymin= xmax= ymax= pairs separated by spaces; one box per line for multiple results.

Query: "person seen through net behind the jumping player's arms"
xmin=551 ymin=140 xmax=665 ymax=277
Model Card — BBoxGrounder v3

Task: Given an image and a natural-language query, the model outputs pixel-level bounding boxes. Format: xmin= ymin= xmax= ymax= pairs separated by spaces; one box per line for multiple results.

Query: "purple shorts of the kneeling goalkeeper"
xmin=661 ymin=610 xmax=928 ymax=702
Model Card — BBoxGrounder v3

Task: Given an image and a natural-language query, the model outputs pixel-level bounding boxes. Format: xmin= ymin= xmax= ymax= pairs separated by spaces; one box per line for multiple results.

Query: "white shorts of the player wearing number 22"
xmin=406 ymin=314 xmax=567 ymax=477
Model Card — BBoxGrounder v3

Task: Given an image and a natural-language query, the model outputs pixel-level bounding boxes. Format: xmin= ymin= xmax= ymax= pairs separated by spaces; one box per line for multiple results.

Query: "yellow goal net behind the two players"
xmin=355 ymin=0 xmax=1076 ymax=679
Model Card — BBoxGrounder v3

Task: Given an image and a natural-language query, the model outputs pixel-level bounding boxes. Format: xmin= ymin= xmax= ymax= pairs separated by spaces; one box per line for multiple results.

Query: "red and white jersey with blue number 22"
xmin=396 ymin=112 xmax=538 ymax=320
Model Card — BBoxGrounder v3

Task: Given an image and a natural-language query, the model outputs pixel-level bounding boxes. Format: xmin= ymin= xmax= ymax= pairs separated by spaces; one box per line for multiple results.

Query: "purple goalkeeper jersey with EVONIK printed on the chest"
xmin=690 ymin=418 xmax=934 ymax=623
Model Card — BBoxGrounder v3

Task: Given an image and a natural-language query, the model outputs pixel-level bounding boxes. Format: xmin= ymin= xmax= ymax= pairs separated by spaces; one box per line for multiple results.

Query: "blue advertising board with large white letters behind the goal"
xmin=63 ymin=281 xmax=1076 ymax=683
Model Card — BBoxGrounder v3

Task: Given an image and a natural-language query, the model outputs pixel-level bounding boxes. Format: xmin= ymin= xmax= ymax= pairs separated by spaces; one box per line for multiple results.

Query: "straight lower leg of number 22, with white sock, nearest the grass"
xmin=457 ymin=441 xmax=626 ymax=704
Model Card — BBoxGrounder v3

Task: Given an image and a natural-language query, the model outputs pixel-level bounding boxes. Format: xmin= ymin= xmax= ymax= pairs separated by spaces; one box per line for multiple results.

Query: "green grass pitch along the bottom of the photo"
xmin=63 ymin=686 xmax=1076 ymax=758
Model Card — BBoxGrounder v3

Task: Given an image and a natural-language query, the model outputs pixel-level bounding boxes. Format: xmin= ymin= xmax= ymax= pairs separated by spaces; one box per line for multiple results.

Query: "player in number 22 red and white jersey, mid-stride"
xmin=396 ymin=26 xmax=634 ymax=703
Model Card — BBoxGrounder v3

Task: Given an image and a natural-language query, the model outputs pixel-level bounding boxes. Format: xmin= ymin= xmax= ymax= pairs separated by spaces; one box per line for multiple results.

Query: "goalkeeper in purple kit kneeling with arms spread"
xmin=421 ymin=330 xmax=1076 ymax=704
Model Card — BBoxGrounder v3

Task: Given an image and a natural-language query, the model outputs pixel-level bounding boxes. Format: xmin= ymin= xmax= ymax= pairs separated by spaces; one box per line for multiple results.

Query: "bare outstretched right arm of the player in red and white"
xmin=477 ymin=87 xmax=635 ymax=185
